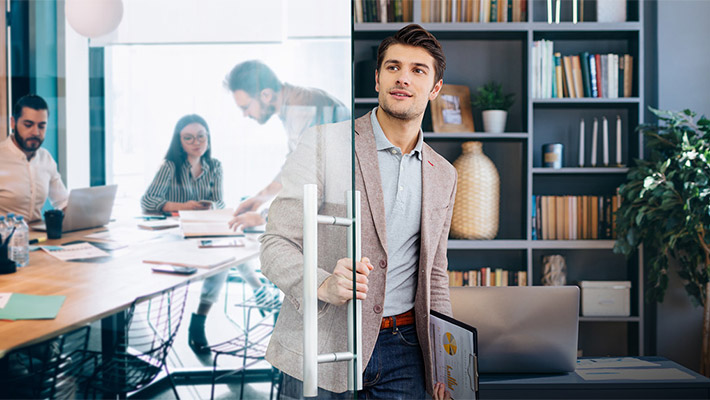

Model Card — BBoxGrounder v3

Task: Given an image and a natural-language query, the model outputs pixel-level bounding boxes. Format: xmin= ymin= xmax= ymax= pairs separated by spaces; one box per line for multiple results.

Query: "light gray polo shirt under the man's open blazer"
xmin=370 ymin=107 xmax=423 ymax=317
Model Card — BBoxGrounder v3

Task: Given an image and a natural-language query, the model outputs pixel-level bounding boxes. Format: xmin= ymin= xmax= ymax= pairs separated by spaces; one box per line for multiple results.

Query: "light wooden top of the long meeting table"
xmin=0 ymin=220 xmax=259 ymax=358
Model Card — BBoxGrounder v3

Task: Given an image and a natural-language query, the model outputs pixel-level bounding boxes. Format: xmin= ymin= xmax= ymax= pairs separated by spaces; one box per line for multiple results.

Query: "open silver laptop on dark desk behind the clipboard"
xmin=449 ymin=286 xmax=579 ymax=373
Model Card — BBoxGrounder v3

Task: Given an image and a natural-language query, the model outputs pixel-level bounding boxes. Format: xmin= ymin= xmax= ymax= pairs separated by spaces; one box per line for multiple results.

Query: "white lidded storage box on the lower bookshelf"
xmin=579 ymin=281 xmax=631 ymax=317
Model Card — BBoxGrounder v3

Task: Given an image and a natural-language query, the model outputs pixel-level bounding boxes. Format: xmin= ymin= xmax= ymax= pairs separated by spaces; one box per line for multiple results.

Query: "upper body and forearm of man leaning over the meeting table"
xmin=224 ymin=60 xmax=350 ymax=227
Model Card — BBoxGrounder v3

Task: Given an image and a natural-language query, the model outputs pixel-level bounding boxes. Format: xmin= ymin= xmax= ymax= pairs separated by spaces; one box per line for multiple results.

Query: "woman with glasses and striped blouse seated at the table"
xmin=141 ymin=114 xmax=224 ymax=213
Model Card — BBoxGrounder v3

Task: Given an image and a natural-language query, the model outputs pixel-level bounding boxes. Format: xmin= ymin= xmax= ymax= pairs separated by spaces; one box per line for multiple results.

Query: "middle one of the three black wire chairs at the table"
xmin=86 ymin=285 xmax=188 ymax=398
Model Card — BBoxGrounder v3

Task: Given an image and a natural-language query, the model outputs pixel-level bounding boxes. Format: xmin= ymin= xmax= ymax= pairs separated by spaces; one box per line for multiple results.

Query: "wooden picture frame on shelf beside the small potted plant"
xmin=431 ymin=85 xmax=475 ymax=133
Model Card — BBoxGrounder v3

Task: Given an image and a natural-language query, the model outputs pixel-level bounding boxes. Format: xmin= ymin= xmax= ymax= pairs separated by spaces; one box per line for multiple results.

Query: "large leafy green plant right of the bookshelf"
xmin=614 ymin=109 xmax=710 ymax=376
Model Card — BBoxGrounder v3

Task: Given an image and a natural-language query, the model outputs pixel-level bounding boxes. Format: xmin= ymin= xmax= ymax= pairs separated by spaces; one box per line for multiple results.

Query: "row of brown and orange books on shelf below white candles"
xmin=532 ymin=195 xmax=621 ymax=240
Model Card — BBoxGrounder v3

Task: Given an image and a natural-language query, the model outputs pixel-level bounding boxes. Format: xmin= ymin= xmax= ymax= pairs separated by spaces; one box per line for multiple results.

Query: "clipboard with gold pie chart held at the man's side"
xmin=429 ymin=311 xmax=478 ymax=399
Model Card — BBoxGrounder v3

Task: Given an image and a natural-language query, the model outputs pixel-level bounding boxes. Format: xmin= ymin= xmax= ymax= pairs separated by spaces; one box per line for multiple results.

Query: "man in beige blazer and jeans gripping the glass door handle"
xmin=261 ymin=24 xmax=456 ymax=399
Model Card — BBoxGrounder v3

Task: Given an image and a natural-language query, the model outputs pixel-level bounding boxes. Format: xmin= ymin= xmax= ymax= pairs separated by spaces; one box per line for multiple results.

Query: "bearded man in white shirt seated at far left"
xmin=0 ymin=94 xmax=69 ymax=221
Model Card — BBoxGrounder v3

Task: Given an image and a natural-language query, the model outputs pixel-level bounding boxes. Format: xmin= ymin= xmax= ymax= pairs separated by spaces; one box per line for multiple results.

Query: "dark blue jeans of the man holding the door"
xmin=279 ymin=324 xmax=431 ymax=399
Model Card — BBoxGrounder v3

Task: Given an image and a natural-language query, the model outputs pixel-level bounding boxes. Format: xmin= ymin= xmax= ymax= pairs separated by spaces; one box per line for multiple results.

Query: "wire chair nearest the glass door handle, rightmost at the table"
xmin=210 ymin=282 xmax=281 ymax=399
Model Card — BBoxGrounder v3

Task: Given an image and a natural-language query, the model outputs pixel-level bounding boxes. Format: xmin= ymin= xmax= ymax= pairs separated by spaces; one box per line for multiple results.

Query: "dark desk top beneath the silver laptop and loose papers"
xmin=479 ymin=357 xmax=710 ymax=400
